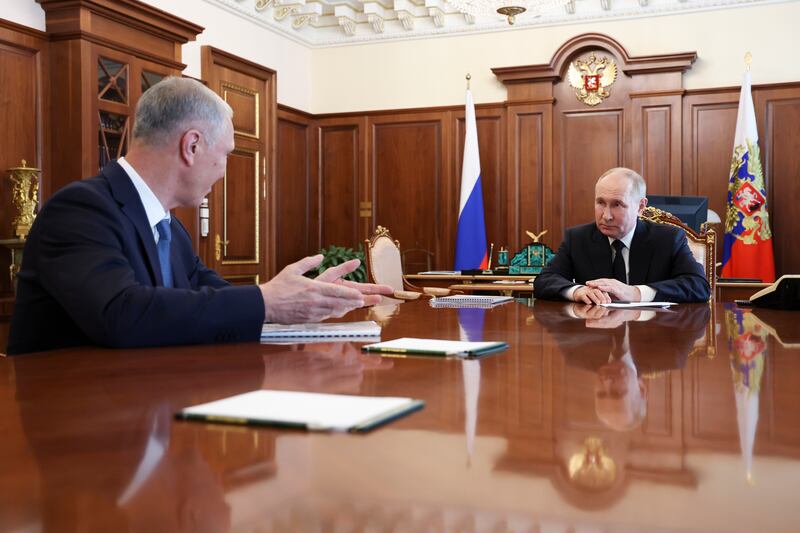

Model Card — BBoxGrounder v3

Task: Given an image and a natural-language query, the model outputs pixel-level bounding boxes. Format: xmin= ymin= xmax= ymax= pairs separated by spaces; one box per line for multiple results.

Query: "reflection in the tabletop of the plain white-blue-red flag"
xmin=458 ymin=308 xmax=486 ymax=461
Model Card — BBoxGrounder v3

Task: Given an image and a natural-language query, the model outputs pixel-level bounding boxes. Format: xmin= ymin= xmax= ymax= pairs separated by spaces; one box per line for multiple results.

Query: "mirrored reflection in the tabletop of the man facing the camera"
xmin=535 ymin=304 xmax=710 ymax=431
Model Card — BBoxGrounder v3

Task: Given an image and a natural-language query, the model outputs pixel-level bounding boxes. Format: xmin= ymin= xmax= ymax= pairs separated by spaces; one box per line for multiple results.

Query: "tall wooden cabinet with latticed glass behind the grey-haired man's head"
xmin=36 ymin=0 xmax=203 ymax=195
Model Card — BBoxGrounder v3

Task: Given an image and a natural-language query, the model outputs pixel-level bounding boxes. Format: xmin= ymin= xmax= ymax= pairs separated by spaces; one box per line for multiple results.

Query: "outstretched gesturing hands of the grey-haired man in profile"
xmin=259 ymin=255 xmax=392 ymax=324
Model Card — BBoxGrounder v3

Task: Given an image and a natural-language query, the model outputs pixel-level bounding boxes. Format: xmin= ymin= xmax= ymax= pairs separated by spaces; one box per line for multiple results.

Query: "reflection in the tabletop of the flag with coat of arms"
xmin=725 ymin=305 xmax=769 ymax=482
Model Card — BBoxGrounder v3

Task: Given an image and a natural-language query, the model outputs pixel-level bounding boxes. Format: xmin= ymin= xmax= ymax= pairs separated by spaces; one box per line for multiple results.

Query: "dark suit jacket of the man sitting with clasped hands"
xmin=533 ymin=220 xmax=711 ymax=302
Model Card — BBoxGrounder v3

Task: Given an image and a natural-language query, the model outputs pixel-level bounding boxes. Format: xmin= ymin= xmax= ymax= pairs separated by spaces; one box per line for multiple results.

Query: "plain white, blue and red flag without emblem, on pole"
xmin=455 ymin=89 xmax=489 ymax=270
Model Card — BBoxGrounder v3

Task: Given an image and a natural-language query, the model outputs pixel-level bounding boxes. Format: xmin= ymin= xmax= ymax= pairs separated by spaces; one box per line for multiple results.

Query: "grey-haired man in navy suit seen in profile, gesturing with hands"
xmin=8 ymin=78 xmax=392 ymax=354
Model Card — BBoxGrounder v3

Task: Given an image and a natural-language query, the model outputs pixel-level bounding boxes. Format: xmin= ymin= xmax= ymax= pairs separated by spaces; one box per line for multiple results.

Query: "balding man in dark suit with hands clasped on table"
xmin=533 ymin=168 xmax=711 ymax=304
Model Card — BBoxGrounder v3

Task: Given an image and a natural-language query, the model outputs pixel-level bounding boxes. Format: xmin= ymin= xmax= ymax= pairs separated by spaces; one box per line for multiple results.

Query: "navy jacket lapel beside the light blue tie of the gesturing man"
xmin=103 ymin=161 xmax=164 ymax=285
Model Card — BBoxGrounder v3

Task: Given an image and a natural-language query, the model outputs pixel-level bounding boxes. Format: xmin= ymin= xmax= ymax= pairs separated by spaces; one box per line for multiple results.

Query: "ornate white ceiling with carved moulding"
xmin=206 ymin=0 xmax=785 ymax=47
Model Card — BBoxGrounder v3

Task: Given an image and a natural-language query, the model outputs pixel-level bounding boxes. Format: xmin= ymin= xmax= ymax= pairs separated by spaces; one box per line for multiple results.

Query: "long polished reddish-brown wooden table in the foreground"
xmin=0 ymin=301 xmax=800 ymax=532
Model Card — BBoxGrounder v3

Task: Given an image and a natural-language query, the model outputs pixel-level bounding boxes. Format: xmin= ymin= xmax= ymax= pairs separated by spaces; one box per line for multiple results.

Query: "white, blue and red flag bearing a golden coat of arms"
xmin=722 ymin=70 xmax=775 ymax=282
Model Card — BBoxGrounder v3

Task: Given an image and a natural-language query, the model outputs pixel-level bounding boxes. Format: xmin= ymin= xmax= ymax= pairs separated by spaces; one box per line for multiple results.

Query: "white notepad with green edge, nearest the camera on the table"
xmin=175 ymin=390 xmax=425 ymax=432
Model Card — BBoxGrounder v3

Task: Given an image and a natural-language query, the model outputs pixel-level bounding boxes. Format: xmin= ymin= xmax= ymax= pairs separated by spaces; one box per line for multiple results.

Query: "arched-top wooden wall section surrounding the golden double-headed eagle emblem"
xmin=492 ymin=33 xmax=696 ymax=252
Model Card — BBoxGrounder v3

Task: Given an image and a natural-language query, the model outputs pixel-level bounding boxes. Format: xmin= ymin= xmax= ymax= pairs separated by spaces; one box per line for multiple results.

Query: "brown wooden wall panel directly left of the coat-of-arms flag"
xmin=681 ymin=89 xmax=739 ymax=261
